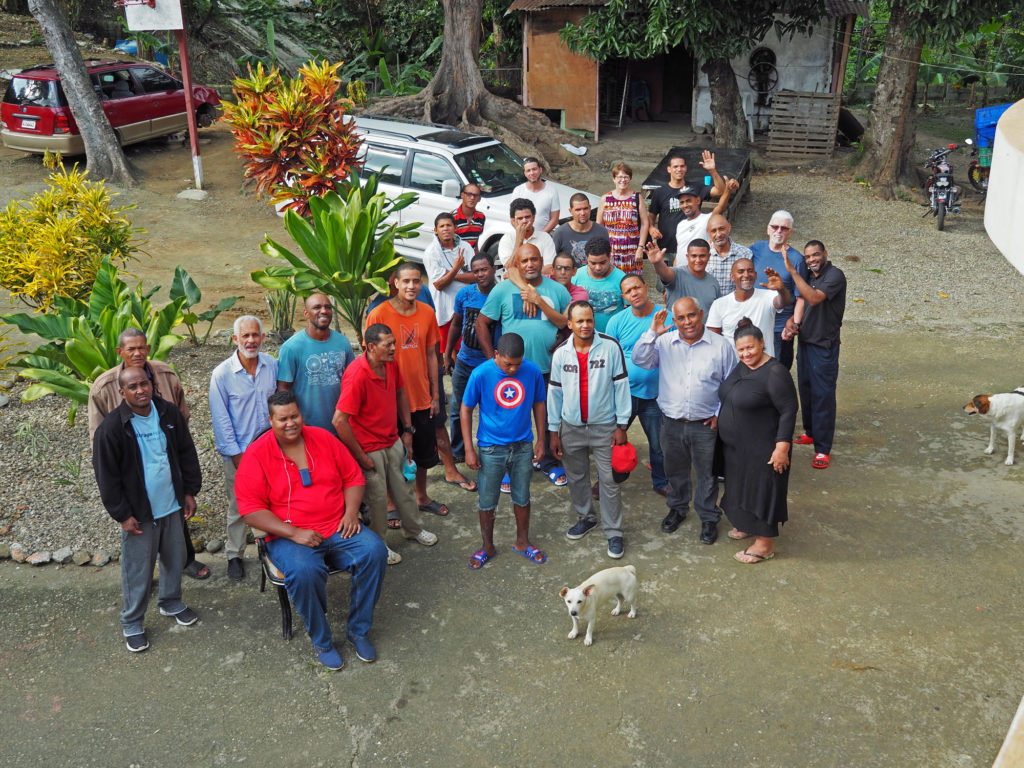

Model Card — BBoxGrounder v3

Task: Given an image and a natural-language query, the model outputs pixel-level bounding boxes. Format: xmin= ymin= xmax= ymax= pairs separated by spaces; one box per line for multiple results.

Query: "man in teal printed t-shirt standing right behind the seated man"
xmin=278 ymin=293 xmax=355 ymax=435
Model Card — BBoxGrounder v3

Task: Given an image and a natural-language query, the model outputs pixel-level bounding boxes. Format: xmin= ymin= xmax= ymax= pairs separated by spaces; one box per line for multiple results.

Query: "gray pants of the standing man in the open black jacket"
xmin=121 ymin=509 xmax=187 ymax=637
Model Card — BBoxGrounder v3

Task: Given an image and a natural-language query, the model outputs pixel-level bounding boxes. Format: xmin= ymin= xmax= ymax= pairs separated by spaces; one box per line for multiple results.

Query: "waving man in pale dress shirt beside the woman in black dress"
xmin=633 ymin=297 xmax=737 ymax=544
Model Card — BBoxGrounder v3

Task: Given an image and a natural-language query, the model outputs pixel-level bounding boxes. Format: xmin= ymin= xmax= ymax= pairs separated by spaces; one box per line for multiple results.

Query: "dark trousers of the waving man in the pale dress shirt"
xmin=662 ymin=417 xmax=722 ymax=523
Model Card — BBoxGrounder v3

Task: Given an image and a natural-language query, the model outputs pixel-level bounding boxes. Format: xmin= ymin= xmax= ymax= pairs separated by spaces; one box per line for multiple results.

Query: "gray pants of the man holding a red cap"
xmin=559 ymin=422 xmax=623 ymax=539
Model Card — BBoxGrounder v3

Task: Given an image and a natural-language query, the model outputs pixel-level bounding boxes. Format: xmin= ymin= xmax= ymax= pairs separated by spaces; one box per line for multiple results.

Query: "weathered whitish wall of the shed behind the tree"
xmin=690 ymin=18 xmax=836 ymax=130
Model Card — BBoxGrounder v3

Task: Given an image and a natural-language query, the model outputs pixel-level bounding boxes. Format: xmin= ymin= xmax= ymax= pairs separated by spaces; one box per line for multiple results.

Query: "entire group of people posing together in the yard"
xmin=89 ymin=153 xmax=846 ymax=669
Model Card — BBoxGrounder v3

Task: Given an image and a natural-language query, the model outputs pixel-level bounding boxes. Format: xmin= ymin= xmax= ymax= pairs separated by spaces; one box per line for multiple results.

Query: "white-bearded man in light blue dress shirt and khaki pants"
xmin=210 ymin=314 xmax=278 ymax=581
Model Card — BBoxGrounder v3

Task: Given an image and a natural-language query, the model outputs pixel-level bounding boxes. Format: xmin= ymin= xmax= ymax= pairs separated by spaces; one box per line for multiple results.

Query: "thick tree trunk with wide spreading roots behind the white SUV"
xmin=373 ymin=0 xmax=581 ymax=167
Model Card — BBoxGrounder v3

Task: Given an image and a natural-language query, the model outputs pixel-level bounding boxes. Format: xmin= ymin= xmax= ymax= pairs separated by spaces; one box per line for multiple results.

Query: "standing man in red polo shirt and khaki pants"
xmin=333 ymin=323 xmax=437 ymax=565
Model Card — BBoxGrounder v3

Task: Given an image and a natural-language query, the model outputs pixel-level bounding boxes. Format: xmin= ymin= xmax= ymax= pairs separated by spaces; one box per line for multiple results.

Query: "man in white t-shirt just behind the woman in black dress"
xmin=708 ymin=259 xmax=790 ymax=357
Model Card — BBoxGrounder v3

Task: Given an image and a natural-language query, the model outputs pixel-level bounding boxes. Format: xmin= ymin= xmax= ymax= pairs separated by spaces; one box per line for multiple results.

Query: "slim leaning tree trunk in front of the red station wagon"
xmin=29 ymin=0 xmax=135 ymax=186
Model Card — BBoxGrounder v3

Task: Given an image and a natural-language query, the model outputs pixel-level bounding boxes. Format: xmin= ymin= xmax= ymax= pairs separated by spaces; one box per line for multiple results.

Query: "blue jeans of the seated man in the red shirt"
xmin=266 ymin=527 xmax=387 ymax=650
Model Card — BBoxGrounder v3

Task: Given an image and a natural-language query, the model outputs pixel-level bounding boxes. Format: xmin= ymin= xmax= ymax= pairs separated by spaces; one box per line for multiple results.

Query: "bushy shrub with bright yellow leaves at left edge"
xmin=0 ymin=155 xmax=142 ymax=311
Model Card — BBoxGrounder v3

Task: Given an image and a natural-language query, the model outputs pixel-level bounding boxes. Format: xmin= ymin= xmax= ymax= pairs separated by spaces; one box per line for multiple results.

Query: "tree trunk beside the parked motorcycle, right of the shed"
xmin=860 ymin=2 xmax=922 ymax=200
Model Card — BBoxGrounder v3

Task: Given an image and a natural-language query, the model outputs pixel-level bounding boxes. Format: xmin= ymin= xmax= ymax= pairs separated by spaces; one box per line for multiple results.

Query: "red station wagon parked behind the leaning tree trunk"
xmin=0 ymin=59 xmax=220 ymax=155
